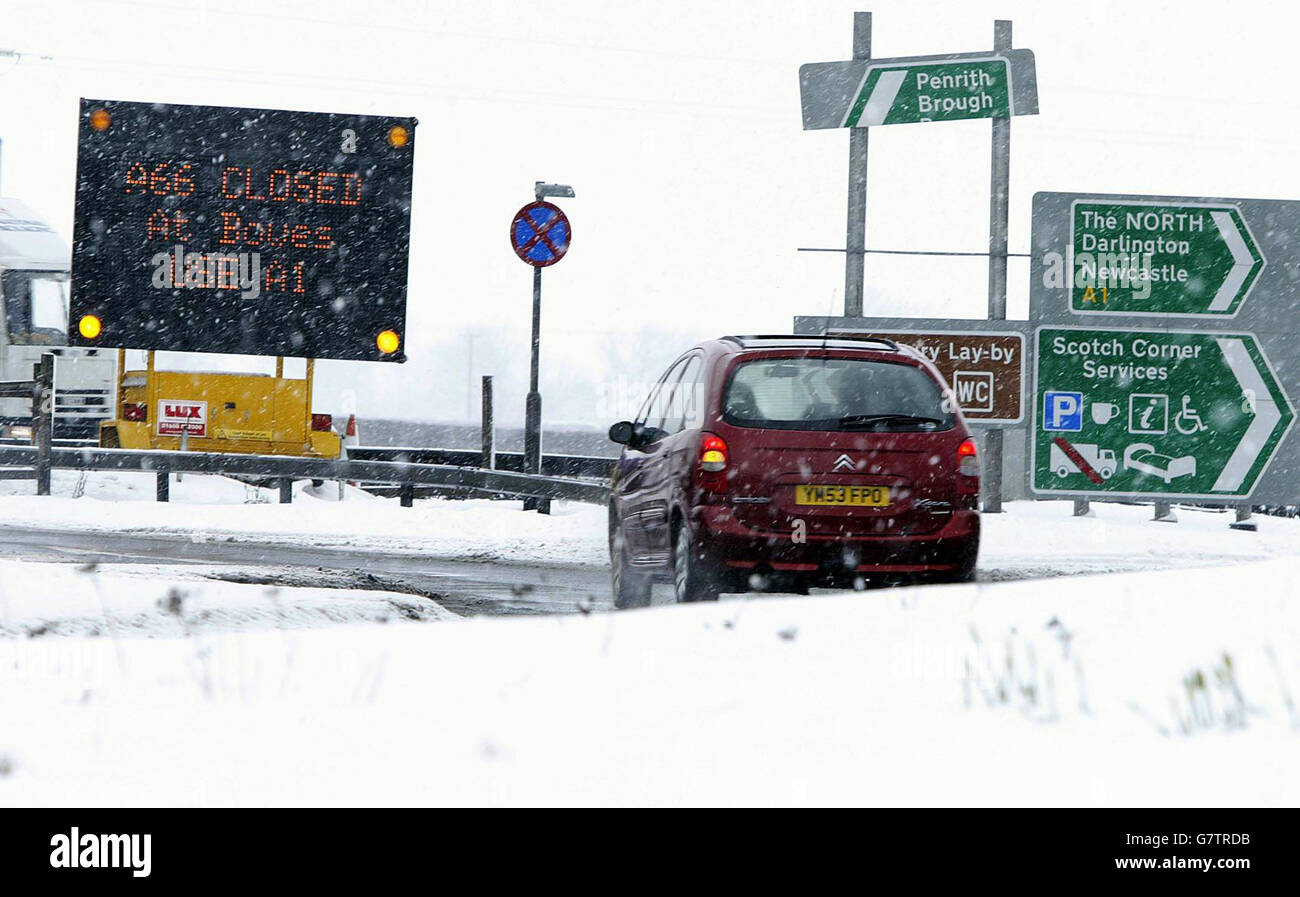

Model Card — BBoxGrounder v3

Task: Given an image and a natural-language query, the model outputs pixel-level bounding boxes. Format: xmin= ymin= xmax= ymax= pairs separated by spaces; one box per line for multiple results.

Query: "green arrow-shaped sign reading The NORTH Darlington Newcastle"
xmin=1067 ymin=200 xmax=1265 ymax=316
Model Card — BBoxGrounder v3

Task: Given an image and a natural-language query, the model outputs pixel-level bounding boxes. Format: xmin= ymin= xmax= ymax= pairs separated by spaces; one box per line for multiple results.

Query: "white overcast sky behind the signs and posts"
xmin=0 ymin=0 xmax=1300 ymax=424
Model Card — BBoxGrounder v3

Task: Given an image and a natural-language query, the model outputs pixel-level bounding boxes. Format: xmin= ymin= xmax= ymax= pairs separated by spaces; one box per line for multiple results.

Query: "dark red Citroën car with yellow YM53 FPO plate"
xmin=610 ymin=337 xmax=980 ymax=607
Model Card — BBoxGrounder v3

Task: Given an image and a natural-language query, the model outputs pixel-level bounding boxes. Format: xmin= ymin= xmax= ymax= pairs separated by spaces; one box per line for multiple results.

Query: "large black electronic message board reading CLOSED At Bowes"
xmin=70 ymin=100 xmax=416 ymax=361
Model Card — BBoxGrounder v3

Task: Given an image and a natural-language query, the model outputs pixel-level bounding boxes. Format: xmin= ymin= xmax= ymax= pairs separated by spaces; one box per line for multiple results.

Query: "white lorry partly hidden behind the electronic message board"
xmin=0 ymin=198 xmax=117 ymax=442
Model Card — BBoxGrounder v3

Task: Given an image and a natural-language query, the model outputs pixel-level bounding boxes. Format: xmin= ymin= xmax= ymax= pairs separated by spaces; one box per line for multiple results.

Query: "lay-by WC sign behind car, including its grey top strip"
xmin=794 ymin=317 xmax=1027 ymax=424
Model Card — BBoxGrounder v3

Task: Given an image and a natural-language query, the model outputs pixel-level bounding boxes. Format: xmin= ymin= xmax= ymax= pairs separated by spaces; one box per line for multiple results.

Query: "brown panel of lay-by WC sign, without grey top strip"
xmin=863 ymin=330 xmax=1024 ymax=424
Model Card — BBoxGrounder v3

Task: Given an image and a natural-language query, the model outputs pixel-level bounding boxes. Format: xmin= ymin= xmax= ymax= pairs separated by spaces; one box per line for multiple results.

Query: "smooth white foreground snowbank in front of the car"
xmin=0 ymin=558 xmax=1300 ymax=805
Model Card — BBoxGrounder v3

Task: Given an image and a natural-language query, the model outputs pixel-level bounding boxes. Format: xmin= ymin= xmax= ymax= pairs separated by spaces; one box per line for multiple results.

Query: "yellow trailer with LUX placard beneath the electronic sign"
xmin=99 ymin=351 xmax=342 ymax=458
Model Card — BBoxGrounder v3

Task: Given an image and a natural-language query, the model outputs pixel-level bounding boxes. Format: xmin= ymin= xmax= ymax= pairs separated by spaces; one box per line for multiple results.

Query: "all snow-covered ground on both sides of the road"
xmin=0 ymin=475 xmax=1300 ymax=805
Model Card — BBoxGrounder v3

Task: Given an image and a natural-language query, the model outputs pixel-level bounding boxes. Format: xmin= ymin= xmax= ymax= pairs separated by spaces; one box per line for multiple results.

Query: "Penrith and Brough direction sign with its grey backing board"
xmin=800 ymin=49 xmax=1039 ymax=130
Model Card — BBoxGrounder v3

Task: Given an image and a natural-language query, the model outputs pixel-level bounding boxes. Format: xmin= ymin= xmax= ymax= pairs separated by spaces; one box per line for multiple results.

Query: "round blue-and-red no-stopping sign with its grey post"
xmin=510 ymin=181 xmax=575 ymax=514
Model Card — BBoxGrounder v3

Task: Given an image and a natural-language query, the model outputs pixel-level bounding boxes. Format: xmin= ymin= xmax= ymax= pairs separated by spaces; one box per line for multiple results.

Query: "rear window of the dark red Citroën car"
xmin=723 ymin=358 xmax=954 ymax=432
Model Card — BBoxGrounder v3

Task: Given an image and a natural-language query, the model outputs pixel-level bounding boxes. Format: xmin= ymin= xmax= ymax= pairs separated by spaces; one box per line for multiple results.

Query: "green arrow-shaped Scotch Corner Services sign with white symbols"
xmin=1030 ymin=326 xmax=1295 ymax=499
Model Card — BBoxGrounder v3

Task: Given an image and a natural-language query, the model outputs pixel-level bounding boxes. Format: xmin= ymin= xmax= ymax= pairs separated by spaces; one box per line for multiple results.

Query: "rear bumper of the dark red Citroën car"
xmin=696 ymin=506 xmax=980 ymax=576
